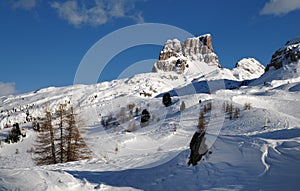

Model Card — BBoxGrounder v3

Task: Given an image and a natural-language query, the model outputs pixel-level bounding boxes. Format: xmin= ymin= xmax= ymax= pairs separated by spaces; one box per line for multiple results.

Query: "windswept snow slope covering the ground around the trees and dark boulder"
xmin=0 ymin=72 xmax=300 ymax=190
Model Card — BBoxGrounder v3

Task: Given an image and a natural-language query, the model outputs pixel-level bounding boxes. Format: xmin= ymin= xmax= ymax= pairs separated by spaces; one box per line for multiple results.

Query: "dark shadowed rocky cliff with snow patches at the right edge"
xmin=266 ymin=37 xmax=300 ymax=71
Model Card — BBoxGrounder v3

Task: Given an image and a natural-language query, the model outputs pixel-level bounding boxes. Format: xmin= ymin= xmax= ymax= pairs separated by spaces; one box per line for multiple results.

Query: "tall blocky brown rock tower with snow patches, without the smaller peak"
xmin=153 ymin=34 xmax=221 ymax=73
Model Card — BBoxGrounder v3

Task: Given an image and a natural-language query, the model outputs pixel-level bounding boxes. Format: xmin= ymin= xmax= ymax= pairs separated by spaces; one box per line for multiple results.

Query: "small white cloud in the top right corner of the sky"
xmin=260 ymin=0 xmax=300 ymax=16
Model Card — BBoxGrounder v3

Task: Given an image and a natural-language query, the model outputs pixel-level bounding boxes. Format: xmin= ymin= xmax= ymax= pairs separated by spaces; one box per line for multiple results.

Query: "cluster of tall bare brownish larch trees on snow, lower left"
xmin=34 ymin=104 xmax=91 ymax=165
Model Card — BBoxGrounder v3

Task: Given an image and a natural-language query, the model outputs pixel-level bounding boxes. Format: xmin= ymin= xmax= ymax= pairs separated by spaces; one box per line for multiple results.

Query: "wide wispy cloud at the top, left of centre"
xmin=51 ymin=0 xmax=143 ymax=27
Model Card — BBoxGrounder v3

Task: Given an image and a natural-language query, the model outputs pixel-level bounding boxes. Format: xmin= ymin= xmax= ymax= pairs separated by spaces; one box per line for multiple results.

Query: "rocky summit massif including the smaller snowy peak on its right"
xmin=152 ymin=34 xmax=265 ymax=81
